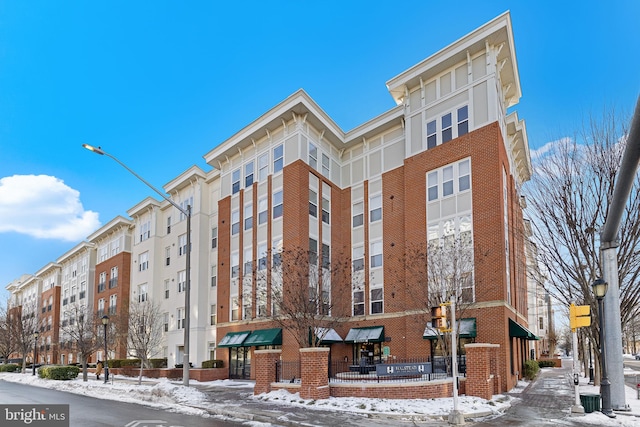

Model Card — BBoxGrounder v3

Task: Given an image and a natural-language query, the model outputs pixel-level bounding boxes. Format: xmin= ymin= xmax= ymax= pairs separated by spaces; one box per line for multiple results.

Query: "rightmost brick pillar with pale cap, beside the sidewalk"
xmin=464 ymin=344 xmax=500 ymax=400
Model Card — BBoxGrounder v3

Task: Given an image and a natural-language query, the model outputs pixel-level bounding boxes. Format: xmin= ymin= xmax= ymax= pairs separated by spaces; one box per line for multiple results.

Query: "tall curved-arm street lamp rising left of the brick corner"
xmin=82 ymin=144 xmax=191 ymax=387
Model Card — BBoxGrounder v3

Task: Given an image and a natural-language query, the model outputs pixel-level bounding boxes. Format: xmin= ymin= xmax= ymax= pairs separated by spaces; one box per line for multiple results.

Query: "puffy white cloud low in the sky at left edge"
xmin=0 ymin=175 xmax=100 ymax=241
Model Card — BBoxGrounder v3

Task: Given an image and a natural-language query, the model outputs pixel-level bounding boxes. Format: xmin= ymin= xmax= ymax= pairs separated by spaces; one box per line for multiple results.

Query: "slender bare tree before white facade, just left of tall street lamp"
xmin=127 ymin=300 xmax=163 ymax=384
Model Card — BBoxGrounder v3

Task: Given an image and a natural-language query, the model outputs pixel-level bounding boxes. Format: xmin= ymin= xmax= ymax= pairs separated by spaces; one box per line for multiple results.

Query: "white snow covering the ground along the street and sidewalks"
xmin=0 ymin=368 xmax=640 ymax=427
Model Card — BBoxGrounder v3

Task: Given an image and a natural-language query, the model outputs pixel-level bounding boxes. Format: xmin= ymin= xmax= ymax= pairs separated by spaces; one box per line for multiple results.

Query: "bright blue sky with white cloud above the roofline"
xmin=0 ymin=0 xmax=640 ymax=299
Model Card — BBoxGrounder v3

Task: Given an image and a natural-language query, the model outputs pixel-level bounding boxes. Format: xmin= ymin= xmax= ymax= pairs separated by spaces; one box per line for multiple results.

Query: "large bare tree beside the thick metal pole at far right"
xmin=524 ymin=106 xmax=640 ymax=382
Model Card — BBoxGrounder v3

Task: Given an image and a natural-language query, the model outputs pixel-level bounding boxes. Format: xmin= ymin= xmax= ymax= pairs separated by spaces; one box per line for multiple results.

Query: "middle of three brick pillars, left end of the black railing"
xmin=300 ymin=347 xmax=331 ymax=400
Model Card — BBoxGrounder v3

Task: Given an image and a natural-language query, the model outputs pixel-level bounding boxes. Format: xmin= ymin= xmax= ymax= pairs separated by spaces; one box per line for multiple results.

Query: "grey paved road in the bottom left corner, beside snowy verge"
xmin=0 ymin=381 xmax=241 ymax=427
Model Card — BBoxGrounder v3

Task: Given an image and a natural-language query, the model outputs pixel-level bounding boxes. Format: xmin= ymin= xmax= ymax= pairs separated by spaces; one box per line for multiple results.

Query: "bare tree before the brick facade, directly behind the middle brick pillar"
xmin=266 ymin=245 xmax=351 ymax=348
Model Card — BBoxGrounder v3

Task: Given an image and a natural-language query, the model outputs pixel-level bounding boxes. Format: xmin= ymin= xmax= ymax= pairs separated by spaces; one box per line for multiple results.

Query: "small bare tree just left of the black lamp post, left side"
xmin=60 ymin=303 xmax=103 ymax=381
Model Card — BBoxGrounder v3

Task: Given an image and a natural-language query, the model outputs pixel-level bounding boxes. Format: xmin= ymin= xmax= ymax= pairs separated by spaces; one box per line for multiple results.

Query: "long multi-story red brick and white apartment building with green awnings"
xmin=7 ymin=12 xmax=536 ymax=390
